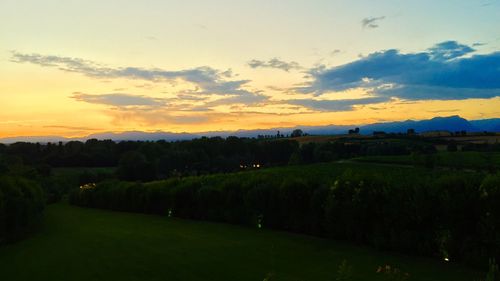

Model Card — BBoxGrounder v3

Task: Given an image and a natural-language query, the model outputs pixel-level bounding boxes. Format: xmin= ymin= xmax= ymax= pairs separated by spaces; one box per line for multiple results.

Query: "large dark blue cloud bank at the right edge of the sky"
xmin=298 ymin=41 xmax=500 ymax=100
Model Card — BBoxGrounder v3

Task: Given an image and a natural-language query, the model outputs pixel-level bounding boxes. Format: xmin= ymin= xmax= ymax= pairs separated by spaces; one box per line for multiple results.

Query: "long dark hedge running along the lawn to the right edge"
xmin=70 ymin=164 xmax=500 ymax=265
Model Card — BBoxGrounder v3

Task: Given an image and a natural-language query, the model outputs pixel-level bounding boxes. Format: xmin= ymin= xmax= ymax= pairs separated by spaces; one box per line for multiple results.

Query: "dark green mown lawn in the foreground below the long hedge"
xmin=0 ymin=204 xmax=478 ymax=281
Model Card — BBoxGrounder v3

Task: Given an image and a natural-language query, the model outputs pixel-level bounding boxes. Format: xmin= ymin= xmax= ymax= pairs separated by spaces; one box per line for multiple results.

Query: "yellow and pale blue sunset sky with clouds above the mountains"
xmin=0 ymin=0 xmax=500 ymax=137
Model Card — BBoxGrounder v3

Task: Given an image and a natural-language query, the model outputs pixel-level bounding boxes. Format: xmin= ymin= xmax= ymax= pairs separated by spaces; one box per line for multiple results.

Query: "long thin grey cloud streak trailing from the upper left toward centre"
xmin=11 ymin=52 xmax=258 ymax=95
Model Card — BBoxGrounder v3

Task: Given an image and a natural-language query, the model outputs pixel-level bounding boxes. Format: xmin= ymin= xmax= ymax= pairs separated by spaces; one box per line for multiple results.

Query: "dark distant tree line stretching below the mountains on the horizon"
xmin=0 ymin=137 xmax=456 ymax=181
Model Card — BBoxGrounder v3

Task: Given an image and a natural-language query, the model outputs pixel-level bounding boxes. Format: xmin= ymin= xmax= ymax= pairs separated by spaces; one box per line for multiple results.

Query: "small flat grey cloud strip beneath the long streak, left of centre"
xmin=72 ymin=92 xmax=166 ymax=107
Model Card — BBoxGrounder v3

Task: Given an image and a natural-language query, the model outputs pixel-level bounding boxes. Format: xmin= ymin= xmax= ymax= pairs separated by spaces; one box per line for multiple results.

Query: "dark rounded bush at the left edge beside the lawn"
xmin=0 ymin=176 xmax=44 ymax=244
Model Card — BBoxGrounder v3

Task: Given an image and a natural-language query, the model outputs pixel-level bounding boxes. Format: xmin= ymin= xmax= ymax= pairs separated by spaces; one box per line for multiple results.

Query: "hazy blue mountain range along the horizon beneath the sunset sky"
xmin=0 ymin=115 xmax=500 ymax=143
